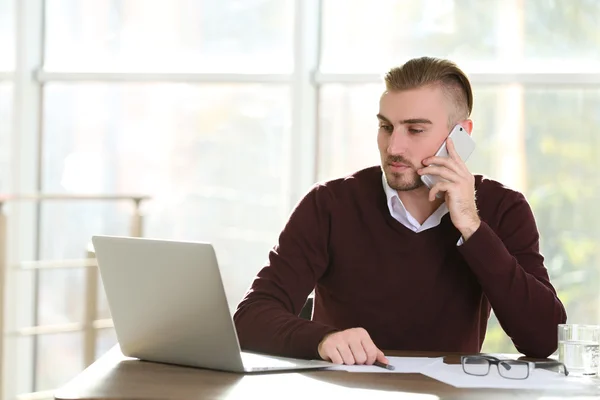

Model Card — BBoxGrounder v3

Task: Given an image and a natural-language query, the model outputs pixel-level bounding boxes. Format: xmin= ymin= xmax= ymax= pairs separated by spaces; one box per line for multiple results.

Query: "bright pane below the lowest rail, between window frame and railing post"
xmin=35 ymin=332 xmax=83 ymax=391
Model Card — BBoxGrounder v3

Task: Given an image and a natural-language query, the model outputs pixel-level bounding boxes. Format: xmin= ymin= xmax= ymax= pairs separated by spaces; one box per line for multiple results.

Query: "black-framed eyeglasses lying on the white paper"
xmin=460 ymin=355 xmax=569 ymax=379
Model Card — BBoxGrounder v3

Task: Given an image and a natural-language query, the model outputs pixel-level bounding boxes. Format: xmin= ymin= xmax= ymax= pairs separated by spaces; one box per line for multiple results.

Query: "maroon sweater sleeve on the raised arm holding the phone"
xmin=459 ymin=193 xmax=567 ymax=357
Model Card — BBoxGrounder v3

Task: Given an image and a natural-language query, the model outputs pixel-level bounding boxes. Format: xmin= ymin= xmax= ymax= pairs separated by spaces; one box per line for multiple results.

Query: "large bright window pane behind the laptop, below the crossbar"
xmin=42 ymin=83 xmax=290 ymax=307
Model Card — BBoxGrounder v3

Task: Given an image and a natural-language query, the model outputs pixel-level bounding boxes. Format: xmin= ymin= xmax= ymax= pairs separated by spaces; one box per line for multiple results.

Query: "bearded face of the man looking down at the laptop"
xmin=377 ymin=85 xmax=453 ymax=191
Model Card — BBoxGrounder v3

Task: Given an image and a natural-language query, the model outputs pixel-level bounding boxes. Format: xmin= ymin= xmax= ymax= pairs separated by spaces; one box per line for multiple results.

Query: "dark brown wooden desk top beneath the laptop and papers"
xmin=56 ymin=347 xmax=600 ymax=400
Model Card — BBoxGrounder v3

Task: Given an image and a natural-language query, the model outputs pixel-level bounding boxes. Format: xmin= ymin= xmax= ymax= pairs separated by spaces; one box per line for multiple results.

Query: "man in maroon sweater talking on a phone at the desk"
xmin=234 ymin=57 xmax=566 ymax=364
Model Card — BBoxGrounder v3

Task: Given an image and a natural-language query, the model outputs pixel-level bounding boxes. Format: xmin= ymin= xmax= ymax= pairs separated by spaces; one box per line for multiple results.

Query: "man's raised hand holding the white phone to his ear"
xmin=418 ymin=138 xmax=481 ymax=241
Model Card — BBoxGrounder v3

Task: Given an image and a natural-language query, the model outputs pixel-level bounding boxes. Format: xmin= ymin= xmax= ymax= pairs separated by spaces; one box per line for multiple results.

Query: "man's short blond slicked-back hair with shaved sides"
xmin=384 ymin=57 xmax=473 ymax=126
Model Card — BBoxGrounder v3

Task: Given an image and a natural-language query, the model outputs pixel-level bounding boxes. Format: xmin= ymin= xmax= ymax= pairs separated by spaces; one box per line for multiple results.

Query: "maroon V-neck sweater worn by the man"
xmin=234 ymin=167 xmax=566 ymax=358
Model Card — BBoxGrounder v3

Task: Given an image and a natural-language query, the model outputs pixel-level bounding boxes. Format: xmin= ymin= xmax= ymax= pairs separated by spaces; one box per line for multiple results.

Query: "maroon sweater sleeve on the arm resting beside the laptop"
xmin=234 ymin=185 xmax=335 ymax=359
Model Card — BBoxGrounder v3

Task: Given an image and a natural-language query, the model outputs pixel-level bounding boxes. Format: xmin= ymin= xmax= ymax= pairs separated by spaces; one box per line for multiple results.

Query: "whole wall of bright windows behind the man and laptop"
xmin=0 ymin=0 xmax=600 ymax=398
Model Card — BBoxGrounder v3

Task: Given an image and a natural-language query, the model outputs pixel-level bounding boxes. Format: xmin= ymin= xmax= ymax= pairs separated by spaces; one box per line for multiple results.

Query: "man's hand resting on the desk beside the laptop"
xmin=318 ymin=328 xmax=389 ymax=365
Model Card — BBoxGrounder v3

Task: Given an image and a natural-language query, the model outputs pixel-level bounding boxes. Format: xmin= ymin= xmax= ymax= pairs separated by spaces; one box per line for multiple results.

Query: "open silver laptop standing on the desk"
xmin=92 ymin=236 xmax=332 ymax=373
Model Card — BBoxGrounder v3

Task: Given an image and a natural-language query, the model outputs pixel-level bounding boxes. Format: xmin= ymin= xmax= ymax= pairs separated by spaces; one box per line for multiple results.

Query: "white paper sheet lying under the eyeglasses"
xmin=421 ymin=359 xmax=600 ymax=390
